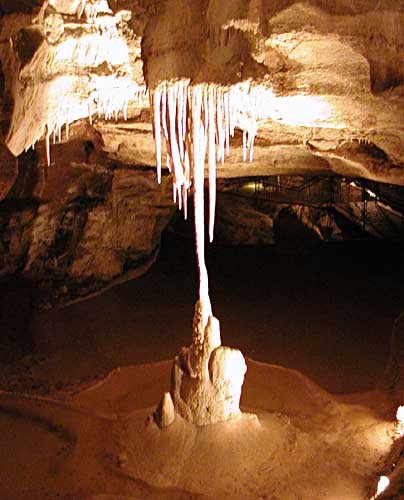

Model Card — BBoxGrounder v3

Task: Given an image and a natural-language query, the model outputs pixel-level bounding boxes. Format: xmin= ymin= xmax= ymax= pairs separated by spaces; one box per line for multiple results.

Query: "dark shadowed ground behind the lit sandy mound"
xmin=2 ymin=229 xmax=404 ymax=393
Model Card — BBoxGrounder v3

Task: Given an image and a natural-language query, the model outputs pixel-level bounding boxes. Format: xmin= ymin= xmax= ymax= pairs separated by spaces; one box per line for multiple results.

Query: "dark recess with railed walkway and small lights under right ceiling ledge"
xmin=218 ymin=175 xmax=404 ymax=240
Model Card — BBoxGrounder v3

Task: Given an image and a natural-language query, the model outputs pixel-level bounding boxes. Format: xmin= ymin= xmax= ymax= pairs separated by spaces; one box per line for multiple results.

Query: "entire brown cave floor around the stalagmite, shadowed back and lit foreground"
xmin=0 ymin=234 xmax=404 ymax=500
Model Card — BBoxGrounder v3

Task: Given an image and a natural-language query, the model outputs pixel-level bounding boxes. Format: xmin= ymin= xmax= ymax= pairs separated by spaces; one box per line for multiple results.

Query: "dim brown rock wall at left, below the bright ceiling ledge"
xmin=0 ymin=158 xmax=174 ymax=307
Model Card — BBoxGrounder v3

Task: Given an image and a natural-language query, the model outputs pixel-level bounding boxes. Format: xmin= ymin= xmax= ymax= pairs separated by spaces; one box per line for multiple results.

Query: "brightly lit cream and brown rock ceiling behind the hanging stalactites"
xmin=0 ymin=0 xmax=404 ymax=197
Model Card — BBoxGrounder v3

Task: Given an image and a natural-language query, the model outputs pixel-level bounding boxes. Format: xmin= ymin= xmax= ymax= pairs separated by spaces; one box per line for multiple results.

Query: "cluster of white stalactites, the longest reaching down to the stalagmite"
xmin=150 ymin=79 xmax=257 ymax=320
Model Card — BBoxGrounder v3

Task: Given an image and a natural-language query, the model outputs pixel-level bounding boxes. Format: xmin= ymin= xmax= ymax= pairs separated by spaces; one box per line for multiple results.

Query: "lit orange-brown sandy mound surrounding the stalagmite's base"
xmin=0 ymin=360 xmax=394 ymax=500
